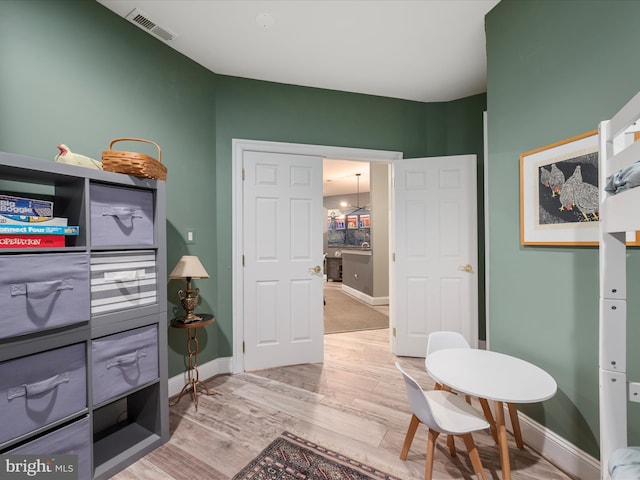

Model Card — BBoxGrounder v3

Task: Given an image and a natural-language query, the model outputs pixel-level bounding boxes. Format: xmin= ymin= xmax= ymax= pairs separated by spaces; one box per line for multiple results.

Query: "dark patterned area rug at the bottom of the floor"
xmin=233 ymin=432 xmax=400 ymax=480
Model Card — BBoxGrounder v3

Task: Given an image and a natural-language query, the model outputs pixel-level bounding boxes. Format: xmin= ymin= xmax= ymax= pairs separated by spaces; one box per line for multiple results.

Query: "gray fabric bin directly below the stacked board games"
xmin=0 ymin=253 xmax=90 ymax=338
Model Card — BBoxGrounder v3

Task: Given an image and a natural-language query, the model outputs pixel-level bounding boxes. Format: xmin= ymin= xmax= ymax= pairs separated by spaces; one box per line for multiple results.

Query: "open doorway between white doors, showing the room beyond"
xmin=322 ymin=158 xmax=391 ymax=334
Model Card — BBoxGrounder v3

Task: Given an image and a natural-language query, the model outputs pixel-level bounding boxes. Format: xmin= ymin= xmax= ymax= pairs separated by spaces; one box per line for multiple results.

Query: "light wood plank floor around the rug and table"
xmin=114 ymin=329 xmax=570 ymax=480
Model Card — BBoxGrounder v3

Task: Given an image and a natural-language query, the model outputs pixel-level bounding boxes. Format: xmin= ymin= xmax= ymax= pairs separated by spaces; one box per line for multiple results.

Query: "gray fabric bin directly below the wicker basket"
xmin=89 ymin=184 xmax=153 ymax=247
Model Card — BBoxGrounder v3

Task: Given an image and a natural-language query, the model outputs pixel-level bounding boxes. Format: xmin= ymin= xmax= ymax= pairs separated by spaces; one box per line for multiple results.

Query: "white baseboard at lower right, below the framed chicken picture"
xmin=505 ymin=405 xmax=600 ymax=480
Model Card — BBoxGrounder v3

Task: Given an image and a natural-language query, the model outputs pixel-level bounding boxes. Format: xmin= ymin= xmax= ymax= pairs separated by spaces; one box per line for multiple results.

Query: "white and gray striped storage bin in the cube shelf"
xmin=91 ymin=250 xmax=158 ymax=316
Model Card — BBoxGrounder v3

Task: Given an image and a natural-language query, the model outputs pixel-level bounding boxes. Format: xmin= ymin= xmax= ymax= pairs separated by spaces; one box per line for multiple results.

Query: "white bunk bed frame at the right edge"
xmin=599 ymin=93 xmax=640 ymax=480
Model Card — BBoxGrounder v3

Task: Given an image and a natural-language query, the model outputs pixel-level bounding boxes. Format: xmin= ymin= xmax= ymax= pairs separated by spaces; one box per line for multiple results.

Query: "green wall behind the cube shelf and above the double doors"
xmin=0 ymin=0 xmax=486 ymax=376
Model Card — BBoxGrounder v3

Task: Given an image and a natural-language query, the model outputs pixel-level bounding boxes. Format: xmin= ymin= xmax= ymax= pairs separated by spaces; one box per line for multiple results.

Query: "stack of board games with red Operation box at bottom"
xmin=0 ymin=194 xmax=80 ymax=248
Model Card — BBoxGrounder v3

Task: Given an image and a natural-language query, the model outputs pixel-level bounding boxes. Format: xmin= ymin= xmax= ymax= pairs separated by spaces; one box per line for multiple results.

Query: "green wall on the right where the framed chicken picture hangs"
xmin=486 ymin=0 xmax=640 ymax=457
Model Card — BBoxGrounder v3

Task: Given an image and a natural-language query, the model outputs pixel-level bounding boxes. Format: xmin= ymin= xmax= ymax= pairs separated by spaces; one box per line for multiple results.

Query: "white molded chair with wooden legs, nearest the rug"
xmin=396 ymin=362 xmax=489 ymax=480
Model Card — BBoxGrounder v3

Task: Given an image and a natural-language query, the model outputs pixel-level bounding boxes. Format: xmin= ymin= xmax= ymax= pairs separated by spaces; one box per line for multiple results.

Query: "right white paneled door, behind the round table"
xmin=391 ymin=155 xmax=478 ymax=357
